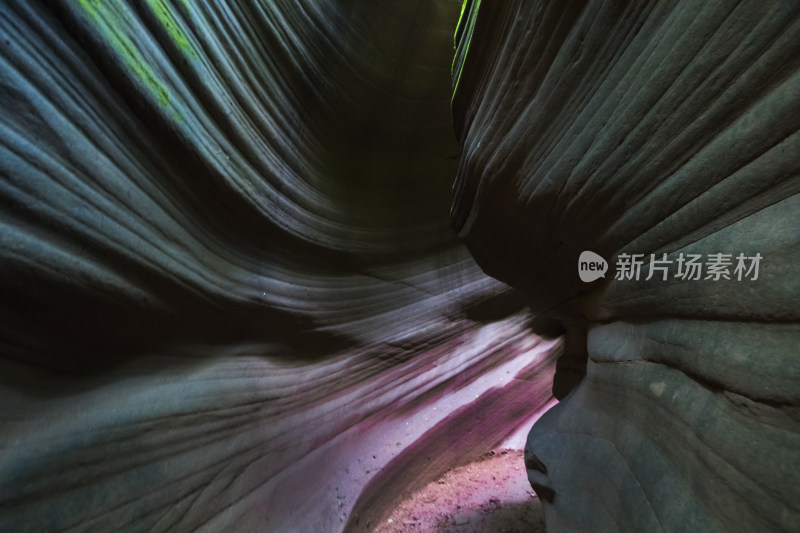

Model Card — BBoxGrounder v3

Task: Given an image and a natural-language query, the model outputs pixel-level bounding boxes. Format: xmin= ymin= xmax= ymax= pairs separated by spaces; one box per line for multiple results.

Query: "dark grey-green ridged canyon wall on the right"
xmin=453 ymin=1 xmax=800 ymax=532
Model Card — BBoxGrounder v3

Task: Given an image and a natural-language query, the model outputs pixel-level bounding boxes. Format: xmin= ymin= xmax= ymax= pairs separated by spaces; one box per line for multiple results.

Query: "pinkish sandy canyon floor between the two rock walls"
xmin=373 ymin=449 xmax=546 ymax=533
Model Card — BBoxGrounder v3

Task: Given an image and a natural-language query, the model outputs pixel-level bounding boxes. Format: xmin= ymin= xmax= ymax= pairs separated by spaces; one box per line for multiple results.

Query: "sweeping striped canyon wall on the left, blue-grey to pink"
xmin=0 ymin=0 xmax=558 ymax=531
